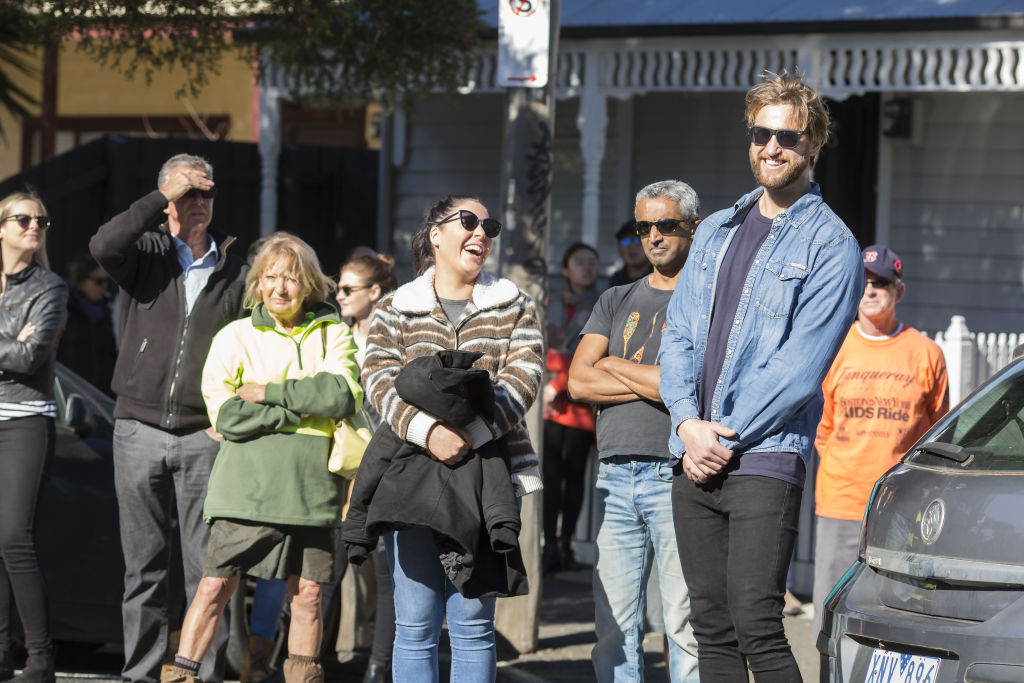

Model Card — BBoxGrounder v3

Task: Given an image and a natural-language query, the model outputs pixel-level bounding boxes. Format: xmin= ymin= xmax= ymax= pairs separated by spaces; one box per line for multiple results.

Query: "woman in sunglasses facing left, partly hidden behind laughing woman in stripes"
xmin=337 ymin=248 xmax=398 ymax=683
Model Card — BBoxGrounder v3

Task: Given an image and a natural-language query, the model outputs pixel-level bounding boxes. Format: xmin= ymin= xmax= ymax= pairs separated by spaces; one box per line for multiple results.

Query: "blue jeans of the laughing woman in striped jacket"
xmin=384 ymin=528 xmax=498 ymax=683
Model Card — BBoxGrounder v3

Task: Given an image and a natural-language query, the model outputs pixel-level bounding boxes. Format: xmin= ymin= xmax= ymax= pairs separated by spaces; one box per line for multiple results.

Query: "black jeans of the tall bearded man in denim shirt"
xmin=672 ymin=475 xmax=803 ymax=683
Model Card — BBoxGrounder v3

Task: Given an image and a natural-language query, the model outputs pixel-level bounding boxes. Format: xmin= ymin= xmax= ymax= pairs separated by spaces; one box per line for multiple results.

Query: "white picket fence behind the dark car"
xmin=926 ymin=315 xmax=1024 ymax=407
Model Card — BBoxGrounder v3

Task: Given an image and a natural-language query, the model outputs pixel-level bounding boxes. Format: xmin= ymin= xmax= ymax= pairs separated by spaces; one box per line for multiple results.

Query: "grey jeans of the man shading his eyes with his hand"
xmin=114 ymin=419 xmax=230 ymax=683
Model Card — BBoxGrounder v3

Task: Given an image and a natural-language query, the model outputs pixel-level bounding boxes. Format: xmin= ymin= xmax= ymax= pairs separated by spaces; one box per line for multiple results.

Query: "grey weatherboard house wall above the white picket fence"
xmin=880 ymin=92 xmax=1024 ymax=332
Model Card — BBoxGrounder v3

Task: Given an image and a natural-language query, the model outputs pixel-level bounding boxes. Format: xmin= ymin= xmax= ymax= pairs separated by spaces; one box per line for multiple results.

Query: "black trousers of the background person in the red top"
xmin=543 ymin=420 xmax=594 ymax=548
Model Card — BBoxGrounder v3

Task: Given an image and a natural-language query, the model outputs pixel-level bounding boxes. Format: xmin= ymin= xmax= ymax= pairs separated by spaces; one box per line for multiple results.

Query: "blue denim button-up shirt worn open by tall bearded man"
xmin=659 ymin=183 xmax=864 ymax=463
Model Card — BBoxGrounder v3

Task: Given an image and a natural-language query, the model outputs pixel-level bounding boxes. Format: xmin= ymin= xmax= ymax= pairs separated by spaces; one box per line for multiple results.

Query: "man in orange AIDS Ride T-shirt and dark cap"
xmin=811 ymin=245 xmax=949 ymax=638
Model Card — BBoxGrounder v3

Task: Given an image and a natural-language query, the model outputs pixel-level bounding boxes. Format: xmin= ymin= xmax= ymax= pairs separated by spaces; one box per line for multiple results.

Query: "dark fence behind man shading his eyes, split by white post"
xmin=0 ymin=135 xmax=378 ymax=274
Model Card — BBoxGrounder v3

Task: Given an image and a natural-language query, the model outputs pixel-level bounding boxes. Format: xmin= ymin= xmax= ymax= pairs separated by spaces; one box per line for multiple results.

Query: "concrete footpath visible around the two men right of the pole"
xmin=495 ymin=569 xmax=818 ymax=683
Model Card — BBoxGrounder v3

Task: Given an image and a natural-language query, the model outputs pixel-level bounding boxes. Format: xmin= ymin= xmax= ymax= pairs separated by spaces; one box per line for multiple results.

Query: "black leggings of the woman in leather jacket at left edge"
xmin=0 ymin=416 xmax=54 ymax=654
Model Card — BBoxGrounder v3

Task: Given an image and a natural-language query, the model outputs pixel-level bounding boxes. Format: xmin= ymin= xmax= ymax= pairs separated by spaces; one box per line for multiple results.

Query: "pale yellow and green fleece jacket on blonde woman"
xmin=203 ymin=304 xmax=362 ymax=526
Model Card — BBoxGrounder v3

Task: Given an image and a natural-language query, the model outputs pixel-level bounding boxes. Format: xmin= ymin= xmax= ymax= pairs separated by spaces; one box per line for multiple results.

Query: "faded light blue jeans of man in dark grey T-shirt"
xmin=591 ymin=456 xmax=697 ymax=683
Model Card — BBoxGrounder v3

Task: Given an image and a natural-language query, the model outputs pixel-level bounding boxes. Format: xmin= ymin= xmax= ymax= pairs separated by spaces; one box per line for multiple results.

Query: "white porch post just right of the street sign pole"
xmin=577 ymin=50 xmax=608 ymax=247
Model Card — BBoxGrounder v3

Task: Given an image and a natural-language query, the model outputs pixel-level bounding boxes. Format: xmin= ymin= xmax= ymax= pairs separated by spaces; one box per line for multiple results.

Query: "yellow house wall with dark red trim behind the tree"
xmin=0 ymin=42 xmax=258 ymax=178
